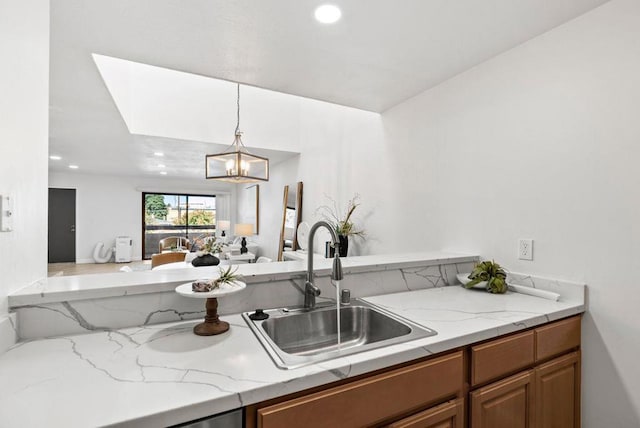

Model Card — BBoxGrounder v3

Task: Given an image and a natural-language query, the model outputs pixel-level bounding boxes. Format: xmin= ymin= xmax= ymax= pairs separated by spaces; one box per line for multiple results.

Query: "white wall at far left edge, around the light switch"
xmin=0 ymin=0 xmax=49 ymax=322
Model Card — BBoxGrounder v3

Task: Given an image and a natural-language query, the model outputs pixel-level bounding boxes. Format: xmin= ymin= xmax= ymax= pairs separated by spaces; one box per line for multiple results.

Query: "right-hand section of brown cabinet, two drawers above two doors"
xmin=469 ymin=316 xmax=580 ymax=428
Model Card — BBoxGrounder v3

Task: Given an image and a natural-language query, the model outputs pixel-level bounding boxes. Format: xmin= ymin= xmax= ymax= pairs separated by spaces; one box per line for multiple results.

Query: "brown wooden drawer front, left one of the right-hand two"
xmin=471 ymin=331 xmax=534 ymax=386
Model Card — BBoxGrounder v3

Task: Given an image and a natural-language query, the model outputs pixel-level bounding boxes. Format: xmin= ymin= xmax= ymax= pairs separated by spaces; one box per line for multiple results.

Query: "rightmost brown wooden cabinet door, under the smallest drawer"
xmin=535 ymin=352 xmax=580 ymax=428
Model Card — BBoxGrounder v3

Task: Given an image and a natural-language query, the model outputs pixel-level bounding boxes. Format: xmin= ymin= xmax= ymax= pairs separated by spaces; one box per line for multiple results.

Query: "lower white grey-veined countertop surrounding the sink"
xmin=0 ymin=284 xmax=585 ymax=427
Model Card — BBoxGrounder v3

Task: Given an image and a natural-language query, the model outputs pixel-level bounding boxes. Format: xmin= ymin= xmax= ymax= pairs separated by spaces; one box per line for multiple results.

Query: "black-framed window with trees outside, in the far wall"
xmin=142 ymin=192 xmax=216 ymax=259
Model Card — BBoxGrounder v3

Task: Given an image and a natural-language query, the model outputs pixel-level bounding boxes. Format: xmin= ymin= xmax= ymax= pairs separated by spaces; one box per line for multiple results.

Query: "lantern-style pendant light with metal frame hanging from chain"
xmin=205 ymin=83 xmax=269 ymax=183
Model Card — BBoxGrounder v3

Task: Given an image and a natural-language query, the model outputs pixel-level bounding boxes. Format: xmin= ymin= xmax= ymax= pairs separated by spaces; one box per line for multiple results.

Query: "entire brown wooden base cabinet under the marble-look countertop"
xmin=245 ymin=316 xmax=580 ymax=428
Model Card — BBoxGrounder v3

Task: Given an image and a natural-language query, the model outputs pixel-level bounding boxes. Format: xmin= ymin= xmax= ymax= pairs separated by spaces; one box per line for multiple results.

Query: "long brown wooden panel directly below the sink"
xmin=257 ymin=351 xmax=464 ymax=428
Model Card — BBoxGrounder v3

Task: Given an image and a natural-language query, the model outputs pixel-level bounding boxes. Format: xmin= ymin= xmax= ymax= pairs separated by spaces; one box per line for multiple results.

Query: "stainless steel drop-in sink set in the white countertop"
xmin=242 ymin=299 xmax=437 ymax=369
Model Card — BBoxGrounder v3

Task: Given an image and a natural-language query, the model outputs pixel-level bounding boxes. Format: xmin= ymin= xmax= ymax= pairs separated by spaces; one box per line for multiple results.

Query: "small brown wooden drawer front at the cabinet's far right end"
xmin=535 ymin=316 xmax=580 ymax=361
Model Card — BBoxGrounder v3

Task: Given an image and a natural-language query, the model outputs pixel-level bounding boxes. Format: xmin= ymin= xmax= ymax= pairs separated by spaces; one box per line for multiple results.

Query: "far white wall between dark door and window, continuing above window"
xmin=49 ymin=172 xmax=233 ymax=263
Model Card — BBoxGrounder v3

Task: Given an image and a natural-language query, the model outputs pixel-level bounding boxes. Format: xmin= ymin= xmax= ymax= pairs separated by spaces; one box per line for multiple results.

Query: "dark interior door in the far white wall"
xmin=49 ymin=189 xmax=76 ymax=263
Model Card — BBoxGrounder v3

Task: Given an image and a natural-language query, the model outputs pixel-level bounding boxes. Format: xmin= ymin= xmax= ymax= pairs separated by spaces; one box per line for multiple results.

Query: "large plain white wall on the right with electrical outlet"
xmin=383 ymin=0 xmax=640 ymax=428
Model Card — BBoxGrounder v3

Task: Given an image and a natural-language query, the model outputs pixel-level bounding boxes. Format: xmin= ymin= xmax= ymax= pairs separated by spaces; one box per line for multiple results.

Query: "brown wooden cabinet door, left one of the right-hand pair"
xmin=470 ymin=370 xmax=535 ymax=428
